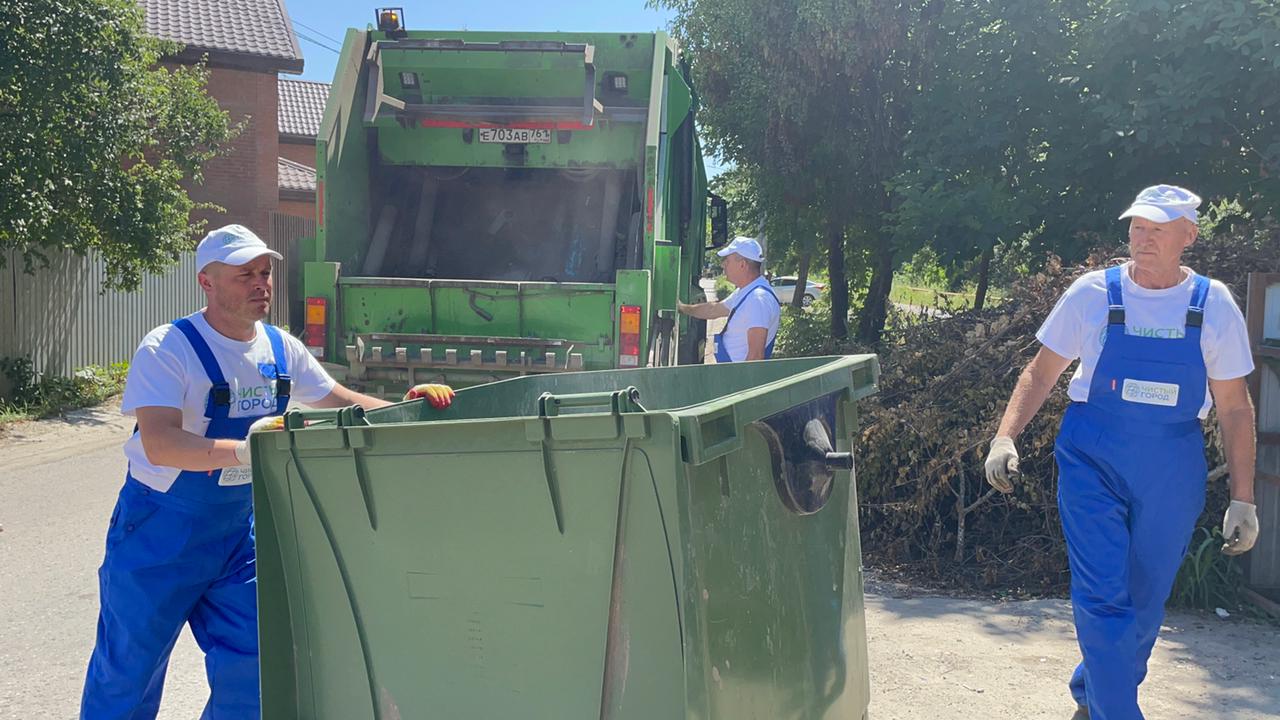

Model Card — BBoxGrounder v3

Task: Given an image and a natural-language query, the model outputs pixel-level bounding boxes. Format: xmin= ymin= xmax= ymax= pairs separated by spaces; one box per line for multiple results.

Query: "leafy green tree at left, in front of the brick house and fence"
xmin=0 ymin=0 xmax=234 ymax=288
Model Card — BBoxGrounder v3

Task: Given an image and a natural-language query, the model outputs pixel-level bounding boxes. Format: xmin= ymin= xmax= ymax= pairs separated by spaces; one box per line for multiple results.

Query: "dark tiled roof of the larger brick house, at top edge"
xmin=138 ymin=0 xmax=302 ymax=70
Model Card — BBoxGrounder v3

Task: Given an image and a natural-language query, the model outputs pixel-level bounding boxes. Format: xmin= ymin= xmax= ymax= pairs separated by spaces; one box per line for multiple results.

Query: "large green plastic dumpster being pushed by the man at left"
xmin=252 ymin=355 xmax=878 ymax=720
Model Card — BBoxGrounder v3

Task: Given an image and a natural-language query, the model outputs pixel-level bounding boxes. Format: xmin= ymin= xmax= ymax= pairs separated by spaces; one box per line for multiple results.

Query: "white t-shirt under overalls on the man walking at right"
xmin=1036 ymin=261 xmax=1253 ymax=418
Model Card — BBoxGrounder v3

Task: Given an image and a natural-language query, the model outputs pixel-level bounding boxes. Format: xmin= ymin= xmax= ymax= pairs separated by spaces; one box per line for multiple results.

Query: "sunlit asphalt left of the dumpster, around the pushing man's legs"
xmin=0 ymin=407 xmax=209 ymax=720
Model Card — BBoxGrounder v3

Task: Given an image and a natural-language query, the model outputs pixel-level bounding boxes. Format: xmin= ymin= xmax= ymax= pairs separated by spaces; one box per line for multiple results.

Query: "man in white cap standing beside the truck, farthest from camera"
xmin=676 ymin=237 xmax=782 ymax=363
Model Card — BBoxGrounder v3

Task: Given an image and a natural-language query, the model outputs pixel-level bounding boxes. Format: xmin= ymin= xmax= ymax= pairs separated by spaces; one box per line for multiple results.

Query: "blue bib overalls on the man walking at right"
xmin=1053 ymin=268 xmax=1208 ymax=720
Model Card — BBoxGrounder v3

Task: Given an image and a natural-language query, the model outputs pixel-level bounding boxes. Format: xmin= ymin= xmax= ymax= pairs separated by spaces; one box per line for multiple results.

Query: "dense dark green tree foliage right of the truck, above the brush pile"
xmin=662 ymin=0 xmax=1280 ymax=341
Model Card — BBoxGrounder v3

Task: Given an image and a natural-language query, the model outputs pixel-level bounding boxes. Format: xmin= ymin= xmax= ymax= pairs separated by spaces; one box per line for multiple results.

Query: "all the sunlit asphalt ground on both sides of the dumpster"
xmin=0 ymin=405 xmax=1280 ymax=720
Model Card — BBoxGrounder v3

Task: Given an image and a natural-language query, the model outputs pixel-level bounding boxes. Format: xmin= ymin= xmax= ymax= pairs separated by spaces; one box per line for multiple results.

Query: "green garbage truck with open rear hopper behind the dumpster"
xmin=291 ymin=9 xmax=728 ymax=388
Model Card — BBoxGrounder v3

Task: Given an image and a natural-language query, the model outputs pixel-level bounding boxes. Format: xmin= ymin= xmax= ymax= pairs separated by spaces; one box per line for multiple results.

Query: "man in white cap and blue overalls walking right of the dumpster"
xmin=986 ymin=184 xmax=1258 ymax=720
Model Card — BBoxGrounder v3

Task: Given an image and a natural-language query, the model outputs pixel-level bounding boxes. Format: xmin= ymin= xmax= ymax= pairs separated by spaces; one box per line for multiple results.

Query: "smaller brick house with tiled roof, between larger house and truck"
xmin=276 ymin=78 xmax=329 ymax=219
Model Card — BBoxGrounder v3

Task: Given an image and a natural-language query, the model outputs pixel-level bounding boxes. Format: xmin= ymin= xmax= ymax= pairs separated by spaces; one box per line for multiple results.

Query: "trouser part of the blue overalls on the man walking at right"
xmin=1055 ymin=405 xmax=1206 ymax=720
